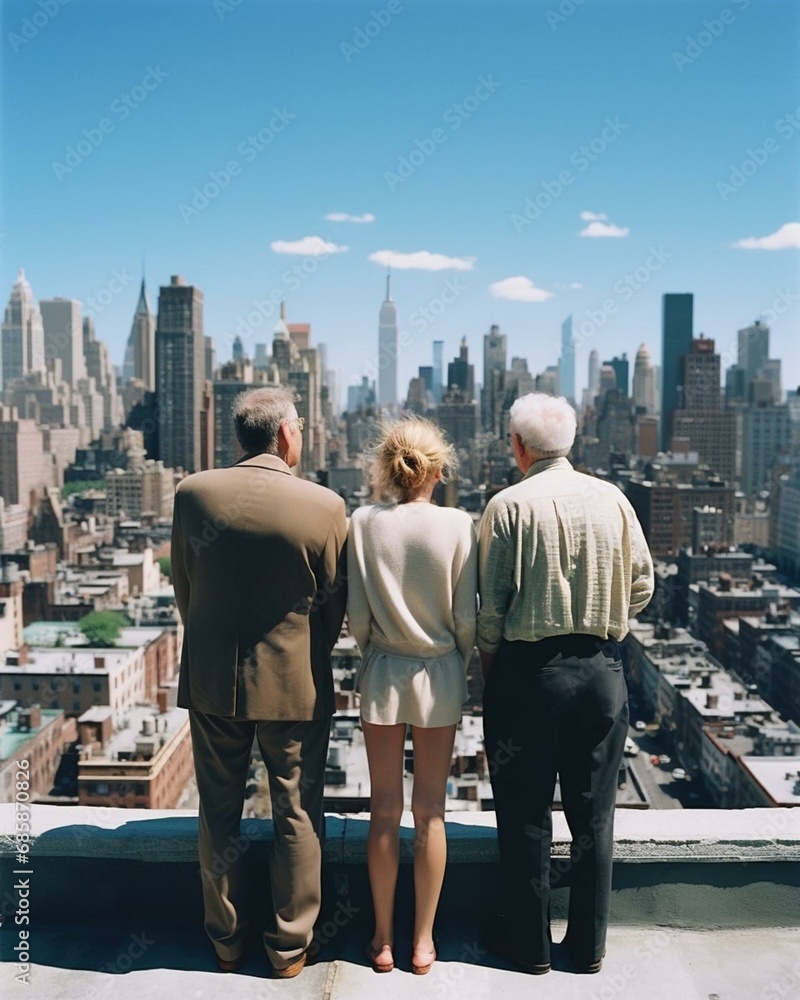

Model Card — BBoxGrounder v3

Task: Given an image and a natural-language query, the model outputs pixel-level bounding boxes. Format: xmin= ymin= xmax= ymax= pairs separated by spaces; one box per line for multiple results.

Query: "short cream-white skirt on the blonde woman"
xmin=355 ymin=643 xmax=467 ymax=729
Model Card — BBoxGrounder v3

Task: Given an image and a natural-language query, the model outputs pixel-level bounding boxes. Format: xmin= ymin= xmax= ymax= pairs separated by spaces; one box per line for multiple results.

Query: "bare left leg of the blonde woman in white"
xmin=361 ymin=719 xmax=406 ymax=966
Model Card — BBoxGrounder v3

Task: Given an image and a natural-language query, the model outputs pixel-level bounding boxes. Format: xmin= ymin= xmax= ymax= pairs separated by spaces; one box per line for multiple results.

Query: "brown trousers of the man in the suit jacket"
xmin=189 ymin=711 xmax=330 ymax=969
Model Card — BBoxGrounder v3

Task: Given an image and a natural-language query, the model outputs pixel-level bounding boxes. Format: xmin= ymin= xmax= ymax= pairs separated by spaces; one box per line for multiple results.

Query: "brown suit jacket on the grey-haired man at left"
xmin=172 ymin=455 xmax=347 ymax=721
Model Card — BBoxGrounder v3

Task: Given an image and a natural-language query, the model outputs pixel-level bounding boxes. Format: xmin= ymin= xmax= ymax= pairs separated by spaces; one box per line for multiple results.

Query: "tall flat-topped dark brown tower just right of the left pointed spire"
xmin=156 ymin=275 xmax=206 ymax=472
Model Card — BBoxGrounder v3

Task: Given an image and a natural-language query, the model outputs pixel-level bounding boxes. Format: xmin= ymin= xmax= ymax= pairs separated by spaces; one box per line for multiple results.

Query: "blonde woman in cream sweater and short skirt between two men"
xmin=347 ymin=419 xmax=477 ymax=975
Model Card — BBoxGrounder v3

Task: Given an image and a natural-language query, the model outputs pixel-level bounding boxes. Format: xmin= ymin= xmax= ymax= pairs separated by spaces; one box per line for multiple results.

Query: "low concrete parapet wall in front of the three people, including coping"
xmin=0 ymin=805 xmax=800 ymax=927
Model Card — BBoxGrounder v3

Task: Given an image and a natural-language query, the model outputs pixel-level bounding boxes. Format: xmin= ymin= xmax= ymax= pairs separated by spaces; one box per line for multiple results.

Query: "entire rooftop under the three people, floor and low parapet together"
xmin=0 ymin=805 xmax=800 ymax=1000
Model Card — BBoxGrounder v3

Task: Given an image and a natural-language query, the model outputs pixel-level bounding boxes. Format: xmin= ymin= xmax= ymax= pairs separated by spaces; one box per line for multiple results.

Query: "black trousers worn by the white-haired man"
xmin=484 ymin=635 xmax=628 ymax=964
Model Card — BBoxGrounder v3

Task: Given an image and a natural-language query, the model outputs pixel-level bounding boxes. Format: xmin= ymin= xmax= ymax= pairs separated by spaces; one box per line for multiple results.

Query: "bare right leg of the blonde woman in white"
xmin=411 ymin=726 xmax=456 ymax=965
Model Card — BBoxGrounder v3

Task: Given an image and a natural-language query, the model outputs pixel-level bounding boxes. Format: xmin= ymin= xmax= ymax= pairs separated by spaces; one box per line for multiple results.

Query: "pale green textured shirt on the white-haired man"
xmin=477 ymin=458 xmax=654 ymax=653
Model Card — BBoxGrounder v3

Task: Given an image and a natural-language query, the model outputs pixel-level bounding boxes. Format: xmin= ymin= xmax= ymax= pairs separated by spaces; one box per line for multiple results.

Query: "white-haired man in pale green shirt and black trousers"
xmin=477 ymin=393 xmax=653 ymax=974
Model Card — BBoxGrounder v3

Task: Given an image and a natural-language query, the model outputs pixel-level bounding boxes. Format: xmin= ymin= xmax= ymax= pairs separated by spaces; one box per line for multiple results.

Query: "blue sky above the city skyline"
xmin=0 ymin=0 xmax=800 ymax=396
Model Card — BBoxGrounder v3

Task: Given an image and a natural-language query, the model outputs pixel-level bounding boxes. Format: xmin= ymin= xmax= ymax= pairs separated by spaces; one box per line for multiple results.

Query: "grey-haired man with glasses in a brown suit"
xmin=172 ymin=388 xmax=346 ymax=978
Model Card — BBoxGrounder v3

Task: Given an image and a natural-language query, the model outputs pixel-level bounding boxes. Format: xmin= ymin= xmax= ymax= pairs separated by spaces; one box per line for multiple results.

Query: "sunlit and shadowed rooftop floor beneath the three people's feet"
xmin=0 ymin=923 xmax=800 ymax=1000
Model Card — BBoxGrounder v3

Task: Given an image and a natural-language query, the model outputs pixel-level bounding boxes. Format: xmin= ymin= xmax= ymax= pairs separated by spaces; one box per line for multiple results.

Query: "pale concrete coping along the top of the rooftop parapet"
xmin=0 ymin=804 xmax=800 ymax=865
